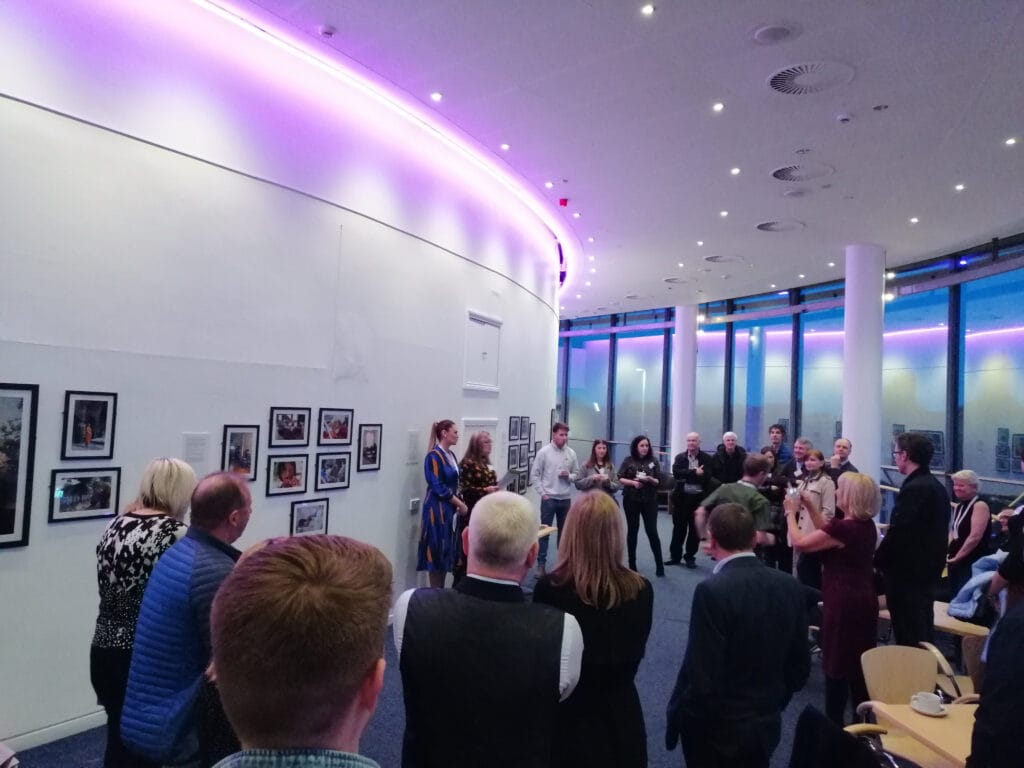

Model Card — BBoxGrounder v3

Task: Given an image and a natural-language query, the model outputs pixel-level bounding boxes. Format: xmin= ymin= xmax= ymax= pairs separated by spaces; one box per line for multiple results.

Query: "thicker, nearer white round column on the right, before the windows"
xmin=843 ymin=244 xmax=888 ymax=479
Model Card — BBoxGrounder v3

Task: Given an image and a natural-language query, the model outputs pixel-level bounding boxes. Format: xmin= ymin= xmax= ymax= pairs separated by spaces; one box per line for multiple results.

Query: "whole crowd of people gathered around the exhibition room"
xmin=79 ymin=420 xmax=1024 ymax=768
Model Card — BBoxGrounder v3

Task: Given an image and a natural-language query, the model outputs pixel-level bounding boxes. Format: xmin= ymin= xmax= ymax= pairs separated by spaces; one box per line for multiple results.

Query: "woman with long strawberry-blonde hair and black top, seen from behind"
xmin=534 ymin=490 xmax=654 ymax=768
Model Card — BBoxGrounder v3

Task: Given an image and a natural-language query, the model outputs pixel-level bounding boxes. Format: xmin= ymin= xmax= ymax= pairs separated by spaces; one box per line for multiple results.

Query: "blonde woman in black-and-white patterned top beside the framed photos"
xmin=89 ymin=459 xmax=196 ymax=768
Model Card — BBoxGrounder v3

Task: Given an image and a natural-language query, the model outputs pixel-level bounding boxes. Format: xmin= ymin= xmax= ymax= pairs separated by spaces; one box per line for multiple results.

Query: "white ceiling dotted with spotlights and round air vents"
xmin=237 ymin=0 xmax=1024 ymax=317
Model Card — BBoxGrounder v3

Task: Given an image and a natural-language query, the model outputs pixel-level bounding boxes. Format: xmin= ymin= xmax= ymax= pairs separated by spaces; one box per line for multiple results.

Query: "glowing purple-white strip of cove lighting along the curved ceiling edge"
xmin=191 ymin=0 xmax=580 ymax=291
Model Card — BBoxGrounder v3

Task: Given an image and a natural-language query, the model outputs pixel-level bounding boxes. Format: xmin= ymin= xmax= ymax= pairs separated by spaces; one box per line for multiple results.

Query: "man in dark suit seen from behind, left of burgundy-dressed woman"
xmin=665 ymin=504 xmax=811 ymax=768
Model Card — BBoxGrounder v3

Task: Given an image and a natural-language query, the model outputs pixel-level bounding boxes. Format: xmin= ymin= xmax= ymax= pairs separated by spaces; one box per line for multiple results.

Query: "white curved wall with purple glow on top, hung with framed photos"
xmin=0 ymin=0 xmax=557 ymax=749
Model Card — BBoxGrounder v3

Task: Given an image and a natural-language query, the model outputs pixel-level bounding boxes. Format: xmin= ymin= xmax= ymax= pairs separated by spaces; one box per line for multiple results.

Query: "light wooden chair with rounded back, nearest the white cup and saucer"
xmin=857 ymin=645 xmax=949 ymax=768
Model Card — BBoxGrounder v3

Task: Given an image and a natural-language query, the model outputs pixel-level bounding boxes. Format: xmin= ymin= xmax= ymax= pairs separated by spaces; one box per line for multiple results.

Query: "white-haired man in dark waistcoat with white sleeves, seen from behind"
xmin=394 ymin=492 xmax=583 ymax=768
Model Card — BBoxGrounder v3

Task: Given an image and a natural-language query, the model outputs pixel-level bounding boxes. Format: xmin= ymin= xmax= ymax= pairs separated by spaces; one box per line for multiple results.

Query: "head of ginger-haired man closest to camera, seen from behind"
xmin=210 ymin=535 xmax=391 ymax=768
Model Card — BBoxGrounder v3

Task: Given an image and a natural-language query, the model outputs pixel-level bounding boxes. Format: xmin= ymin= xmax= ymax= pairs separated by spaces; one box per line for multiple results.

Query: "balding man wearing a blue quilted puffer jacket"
xmin=121 ymin=472 xmax=253 ymax=766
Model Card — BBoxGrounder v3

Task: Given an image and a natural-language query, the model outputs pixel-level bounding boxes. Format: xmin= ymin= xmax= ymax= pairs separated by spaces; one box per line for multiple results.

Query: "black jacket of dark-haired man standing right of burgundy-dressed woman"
xmin=874 ymin=467 xmax=949 ymax=585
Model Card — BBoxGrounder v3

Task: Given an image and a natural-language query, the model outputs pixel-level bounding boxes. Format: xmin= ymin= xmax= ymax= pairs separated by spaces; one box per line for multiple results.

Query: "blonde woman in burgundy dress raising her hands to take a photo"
xmin=784 ymin=472 xmax=882 ymax=725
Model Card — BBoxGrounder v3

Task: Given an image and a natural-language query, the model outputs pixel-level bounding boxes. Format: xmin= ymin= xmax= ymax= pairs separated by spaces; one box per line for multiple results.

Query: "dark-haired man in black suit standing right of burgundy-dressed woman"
xmin=874 ymin=432 xmax=949 ymax=646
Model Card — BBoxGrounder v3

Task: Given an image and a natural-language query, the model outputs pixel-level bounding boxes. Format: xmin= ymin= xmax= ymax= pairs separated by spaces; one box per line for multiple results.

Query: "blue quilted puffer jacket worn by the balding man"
xmin=121 ymin=526 xmax=242 ymax=765
